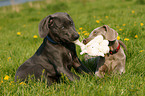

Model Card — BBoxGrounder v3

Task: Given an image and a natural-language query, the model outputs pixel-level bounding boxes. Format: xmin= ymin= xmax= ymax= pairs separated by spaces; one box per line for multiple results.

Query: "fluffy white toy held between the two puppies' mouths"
xmin=74 ymin=35 xmax=109 ymax=57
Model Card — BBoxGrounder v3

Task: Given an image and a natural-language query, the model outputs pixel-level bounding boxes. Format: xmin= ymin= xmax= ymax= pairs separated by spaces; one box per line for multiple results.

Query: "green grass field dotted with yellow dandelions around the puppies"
xmin=0 ymin=0 xmax=145 ymax=96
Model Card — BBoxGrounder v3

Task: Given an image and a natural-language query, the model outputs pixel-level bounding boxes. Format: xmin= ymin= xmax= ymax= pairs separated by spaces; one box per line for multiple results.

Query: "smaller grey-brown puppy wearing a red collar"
xmin=83 ymin=25 xmax=126 ymax=78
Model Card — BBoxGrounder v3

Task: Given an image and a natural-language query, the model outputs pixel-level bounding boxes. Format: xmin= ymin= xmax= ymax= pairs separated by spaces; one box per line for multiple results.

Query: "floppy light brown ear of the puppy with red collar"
xmin=103 ymin=25 xmax=118 ymax=41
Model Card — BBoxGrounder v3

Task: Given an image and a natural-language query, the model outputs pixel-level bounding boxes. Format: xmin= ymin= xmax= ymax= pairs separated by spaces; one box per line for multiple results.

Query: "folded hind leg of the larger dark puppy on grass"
xmin=15 ymin=64 xmax=53 ymax=85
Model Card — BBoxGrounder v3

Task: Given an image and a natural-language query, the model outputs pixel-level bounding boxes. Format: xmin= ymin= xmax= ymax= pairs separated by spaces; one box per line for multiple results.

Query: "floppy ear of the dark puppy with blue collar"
xmin=39 ymin=15 xmax=53 ymax=38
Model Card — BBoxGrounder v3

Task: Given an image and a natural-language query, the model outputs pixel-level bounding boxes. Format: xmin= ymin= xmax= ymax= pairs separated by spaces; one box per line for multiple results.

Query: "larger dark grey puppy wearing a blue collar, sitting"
xmin=15 ymin=12 xmax=91 ymax=85
